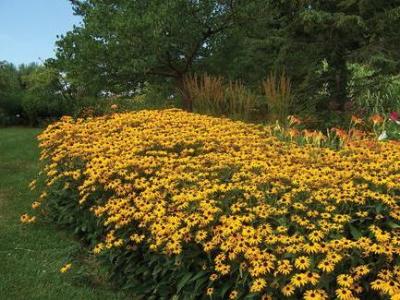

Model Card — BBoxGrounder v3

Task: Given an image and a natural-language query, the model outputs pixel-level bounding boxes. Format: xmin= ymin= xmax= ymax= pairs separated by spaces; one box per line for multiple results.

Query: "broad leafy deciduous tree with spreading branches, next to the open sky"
xmin=53 ymin=0 xmax=250 ymax=109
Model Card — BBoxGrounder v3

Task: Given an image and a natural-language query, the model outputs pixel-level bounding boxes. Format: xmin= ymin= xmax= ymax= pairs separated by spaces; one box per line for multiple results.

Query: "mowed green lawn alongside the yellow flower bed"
xmin=0 ymin=128 xmax=127 ymax=300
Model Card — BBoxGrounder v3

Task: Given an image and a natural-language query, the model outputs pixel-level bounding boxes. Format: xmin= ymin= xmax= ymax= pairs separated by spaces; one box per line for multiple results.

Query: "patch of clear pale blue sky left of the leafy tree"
xmin=0 ymin=0 xmax=79 ymax=65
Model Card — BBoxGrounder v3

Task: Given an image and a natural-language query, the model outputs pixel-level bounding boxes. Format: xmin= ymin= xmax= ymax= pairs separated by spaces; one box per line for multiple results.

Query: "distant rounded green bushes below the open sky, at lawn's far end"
xmin=0 ymin=63 xmax=70 ymax=125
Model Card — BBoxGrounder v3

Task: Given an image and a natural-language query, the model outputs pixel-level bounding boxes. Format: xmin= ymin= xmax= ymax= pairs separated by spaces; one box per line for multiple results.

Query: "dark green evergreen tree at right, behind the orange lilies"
xmin=258 ymin=0 xmax=400 ymax=109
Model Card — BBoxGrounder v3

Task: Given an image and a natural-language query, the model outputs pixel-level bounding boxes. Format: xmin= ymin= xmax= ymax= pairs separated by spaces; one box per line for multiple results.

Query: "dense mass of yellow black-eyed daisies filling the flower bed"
xmin=34 ymin=109 xmax=400 ymax=300
